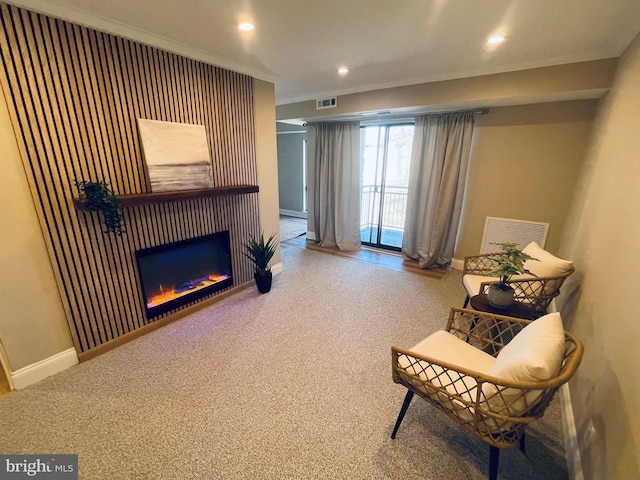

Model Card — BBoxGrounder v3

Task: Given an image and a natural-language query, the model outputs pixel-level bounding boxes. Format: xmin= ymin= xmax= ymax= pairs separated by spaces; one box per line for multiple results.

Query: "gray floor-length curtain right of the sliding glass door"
xmin=402 ymin=112 xmax=474 ymax=268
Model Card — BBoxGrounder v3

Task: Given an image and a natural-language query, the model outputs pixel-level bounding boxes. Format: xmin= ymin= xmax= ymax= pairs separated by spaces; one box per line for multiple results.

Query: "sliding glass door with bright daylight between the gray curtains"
xmin=360 ymin=124 xmax=413 ymax=251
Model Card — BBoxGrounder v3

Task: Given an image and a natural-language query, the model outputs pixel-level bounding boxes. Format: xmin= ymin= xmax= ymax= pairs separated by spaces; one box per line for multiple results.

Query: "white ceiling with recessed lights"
xmin=8 ymin=0 xmax=640 ymax=104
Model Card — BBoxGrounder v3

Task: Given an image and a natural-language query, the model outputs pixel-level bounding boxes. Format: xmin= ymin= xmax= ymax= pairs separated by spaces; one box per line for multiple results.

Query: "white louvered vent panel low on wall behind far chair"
xmin=480 ymin=217 xmax=549 ymax=253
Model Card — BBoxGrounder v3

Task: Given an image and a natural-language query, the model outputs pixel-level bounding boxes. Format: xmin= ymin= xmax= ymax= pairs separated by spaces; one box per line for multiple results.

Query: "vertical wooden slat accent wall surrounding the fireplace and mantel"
xmin=0 ymin=3 xmax=259 ymax=353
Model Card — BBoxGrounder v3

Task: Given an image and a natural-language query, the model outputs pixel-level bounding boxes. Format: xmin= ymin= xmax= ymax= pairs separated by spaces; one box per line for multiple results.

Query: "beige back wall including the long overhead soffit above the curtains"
xmin=276 ymin=59 xmax=604 ymax=260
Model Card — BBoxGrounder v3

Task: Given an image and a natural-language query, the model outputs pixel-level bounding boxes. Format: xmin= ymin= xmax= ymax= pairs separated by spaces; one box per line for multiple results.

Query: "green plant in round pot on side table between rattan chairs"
xmin=487 ymin=242 xmax=537 ymax=308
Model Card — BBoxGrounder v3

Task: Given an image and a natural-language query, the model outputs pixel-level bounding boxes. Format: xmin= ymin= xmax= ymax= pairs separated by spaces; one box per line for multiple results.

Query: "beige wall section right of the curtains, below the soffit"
xmin=455 ymin=100 xmax=597 ymax=259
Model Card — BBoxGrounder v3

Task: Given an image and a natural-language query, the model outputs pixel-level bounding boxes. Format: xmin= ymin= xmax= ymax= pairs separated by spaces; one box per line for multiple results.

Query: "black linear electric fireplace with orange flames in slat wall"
xmin=136 ymin=230 xmax=233 ymax=318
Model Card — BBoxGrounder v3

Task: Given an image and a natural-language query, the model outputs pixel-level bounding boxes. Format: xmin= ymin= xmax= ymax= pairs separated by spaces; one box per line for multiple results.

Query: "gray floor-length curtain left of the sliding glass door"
xmin=307 ymin=122 xmax=360 ymax=250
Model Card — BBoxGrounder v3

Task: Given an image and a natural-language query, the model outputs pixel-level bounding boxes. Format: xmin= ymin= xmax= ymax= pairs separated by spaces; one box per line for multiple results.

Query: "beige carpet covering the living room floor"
xmin=0 ymin=248 xmax=567 ymax=480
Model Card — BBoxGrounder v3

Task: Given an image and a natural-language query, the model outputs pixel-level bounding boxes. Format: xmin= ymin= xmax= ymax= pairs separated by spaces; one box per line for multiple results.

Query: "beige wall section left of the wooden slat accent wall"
xmin=0 ymin=88 xmax=73 ymax=372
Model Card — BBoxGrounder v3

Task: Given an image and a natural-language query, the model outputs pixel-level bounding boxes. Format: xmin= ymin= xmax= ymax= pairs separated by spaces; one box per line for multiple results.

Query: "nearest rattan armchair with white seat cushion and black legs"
xmin=391 ymin=308 xmax=583 ymax=480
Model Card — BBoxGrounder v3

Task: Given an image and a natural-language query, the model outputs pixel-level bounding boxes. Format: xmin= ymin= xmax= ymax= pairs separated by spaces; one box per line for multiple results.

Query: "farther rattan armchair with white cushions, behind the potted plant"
xmin=462 ymin=242 xmax=574 ymax=318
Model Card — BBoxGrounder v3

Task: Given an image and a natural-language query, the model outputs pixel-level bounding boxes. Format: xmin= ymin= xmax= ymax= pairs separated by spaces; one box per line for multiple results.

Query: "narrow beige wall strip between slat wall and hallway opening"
xmin=253 ymin=79 xmax=282 ymax=265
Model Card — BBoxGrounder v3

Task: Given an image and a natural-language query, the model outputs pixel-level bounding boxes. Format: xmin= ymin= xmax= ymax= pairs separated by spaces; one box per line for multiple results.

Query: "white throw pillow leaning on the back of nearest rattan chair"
xmin=482 ymin=313 xmax=565 ymax=416
